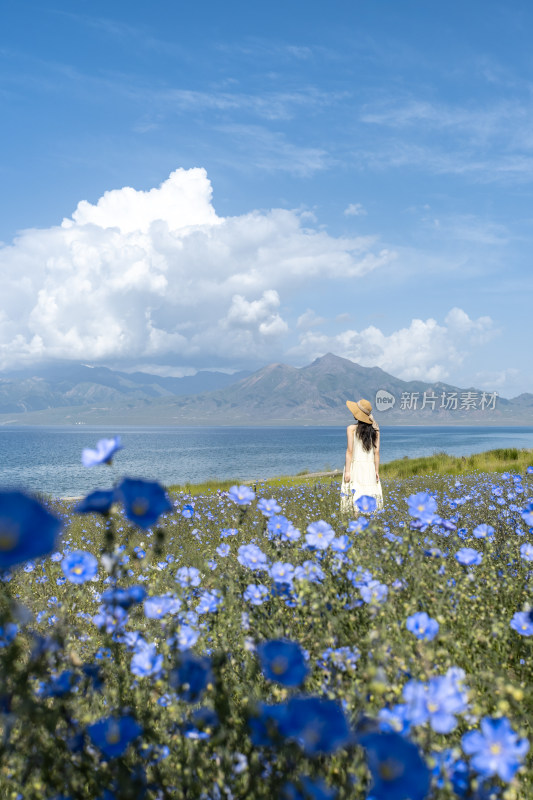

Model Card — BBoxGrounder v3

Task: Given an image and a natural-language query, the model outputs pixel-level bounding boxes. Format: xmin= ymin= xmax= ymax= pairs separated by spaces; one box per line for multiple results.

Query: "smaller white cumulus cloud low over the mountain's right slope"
xmin=293 ymin=308 xmax=497 ymax=381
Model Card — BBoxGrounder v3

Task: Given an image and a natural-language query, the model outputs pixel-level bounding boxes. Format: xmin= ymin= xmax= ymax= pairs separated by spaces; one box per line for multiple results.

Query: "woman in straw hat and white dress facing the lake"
xmin=341 ymin=400 xmax=383 ymax=514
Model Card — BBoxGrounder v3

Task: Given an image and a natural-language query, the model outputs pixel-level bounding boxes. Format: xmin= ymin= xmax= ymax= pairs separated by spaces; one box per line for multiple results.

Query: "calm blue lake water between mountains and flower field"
xmin=0 ymin=425 xmax=533 ymax=497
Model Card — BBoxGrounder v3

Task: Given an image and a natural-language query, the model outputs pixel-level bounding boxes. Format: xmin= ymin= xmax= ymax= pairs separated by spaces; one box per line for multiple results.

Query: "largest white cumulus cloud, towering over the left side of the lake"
xmin=0 ymin=169 xmax=394 ymax=369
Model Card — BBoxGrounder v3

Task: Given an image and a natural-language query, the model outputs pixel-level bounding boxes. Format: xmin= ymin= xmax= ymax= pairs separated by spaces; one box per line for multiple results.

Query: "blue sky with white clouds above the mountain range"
xmin=0 ymin=0 xmax=533 ymax=397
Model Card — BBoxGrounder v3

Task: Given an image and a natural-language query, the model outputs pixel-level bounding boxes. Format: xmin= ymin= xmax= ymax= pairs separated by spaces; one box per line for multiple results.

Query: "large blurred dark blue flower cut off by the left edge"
xmin=0 ymin=491 xmax=62 ymax=569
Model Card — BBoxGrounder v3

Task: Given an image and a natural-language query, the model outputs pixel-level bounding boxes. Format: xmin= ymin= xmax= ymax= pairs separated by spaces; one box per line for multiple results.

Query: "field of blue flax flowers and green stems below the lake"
xmin=0 ymin=440 xmax=533 ymax=800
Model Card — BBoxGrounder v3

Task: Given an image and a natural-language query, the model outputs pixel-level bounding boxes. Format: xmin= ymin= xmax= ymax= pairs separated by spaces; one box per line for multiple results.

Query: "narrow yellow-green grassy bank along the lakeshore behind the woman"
xmin=169 ymin=447 xmax=533 ymax=495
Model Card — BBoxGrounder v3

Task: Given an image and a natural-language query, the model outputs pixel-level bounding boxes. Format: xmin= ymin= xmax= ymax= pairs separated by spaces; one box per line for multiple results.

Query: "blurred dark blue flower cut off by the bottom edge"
xmin=360 ymin=733 xmax=430 ymax=800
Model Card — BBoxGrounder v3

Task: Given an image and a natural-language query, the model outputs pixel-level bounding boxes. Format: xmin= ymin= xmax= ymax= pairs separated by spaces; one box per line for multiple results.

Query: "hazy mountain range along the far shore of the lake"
xmin=0 ymin=353 xmax=533 ymax=425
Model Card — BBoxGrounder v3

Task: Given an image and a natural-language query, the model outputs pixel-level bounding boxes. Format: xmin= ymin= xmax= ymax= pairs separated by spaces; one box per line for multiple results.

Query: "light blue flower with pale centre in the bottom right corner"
xmin=461 ymin=717 xmax=529 ymax=783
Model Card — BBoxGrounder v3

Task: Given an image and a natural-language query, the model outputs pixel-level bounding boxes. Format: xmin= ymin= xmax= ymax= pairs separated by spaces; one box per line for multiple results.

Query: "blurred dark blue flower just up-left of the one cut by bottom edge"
xmin=279 ymin=697 xmax=352 ymax=756
